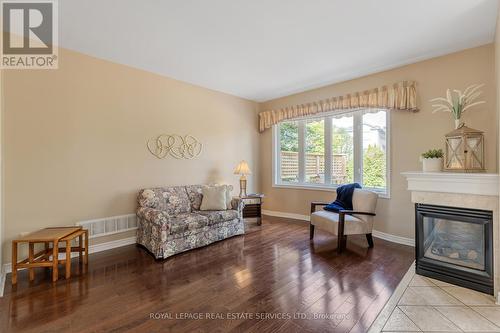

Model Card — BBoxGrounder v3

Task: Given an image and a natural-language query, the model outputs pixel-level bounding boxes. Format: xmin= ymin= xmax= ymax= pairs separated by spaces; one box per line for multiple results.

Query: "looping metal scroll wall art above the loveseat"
xmin=148 ymin=134 xmax=203 ymax=160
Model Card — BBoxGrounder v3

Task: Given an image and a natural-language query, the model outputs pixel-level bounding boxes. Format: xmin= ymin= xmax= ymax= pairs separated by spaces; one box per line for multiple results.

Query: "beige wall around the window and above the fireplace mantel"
xmin=260 ymin=44 xmax=497 ymax=238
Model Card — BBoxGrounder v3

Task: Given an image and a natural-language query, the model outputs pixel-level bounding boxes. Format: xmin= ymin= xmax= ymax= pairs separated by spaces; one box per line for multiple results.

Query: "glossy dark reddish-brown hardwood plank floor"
xmin=0 ymin=218 xmax=414 ymax=332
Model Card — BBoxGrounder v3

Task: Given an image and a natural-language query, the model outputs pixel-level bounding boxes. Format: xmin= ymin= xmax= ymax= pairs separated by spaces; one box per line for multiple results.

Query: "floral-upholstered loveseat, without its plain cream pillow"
xmin=137 ymin=185 xmax=245 ymax=259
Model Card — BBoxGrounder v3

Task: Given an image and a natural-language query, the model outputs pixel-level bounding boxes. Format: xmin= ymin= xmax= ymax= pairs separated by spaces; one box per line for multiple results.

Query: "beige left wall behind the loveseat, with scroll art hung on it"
xmin=3 ymin=46 xmax=259 ymax=262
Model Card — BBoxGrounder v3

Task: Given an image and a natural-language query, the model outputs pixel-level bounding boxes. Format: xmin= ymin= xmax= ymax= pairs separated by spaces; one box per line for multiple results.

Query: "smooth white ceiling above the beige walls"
xmin=59 ymin=0 xmax=497 ymax=101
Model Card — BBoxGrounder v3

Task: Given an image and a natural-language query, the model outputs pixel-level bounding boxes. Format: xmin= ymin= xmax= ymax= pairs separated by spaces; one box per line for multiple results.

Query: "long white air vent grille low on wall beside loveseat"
xmin=76 ymin=214 xmax=137 ymax=238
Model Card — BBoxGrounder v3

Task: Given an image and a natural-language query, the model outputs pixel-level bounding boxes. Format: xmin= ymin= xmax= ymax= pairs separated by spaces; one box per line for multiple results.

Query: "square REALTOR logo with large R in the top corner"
xmin=1 ymin=0 xmax=58 ymax=69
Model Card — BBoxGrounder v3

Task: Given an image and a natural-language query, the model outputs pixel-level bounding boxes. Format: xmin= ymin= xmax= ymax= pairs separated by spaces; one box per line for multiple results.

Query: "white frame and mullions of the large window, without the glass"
xmin=272 ymin=110 xmax=392 ymax=199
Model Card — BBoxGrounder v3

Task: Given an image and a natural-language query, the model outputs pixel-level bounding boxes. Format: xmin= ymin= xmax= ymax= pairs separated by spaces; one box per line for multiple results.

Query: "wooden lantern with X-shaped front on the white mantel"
xmin=444 ymin=124 xmax=485 ymax=172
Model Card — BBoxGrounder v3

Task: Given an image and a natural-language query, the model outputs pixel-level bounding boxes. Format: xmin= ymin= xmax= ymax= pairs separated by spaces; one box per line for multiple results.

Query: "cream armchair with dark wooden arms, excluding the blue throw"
xmin=309 ymin=189 xmax=378 ymax=254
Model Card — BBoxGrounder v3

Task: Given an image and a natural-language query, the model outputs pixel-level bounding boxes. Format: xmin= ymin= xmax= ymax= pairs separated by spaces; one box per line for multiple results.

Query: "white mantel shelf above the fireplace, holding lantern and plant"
xmin=401 ymin=171 xmax=499 ymax=196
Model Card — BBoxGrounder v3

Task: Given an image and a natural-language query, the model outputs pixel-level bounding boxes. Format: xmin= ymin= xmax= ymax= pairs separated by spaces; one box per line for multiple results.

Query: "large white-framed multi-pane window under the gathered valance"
xmin=274 ymin=109 xmax=389 ymax=195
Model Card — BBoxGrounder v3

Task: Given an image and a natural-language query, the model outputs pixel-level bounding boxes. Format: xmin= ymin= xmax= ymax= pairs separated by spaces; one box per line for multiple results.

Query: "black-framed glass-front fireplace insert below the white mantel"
xmin=415 ymin=203 xmax=493 ymax=294
